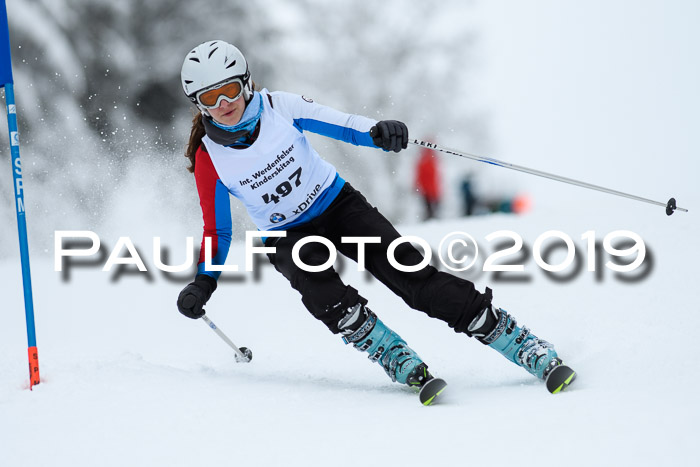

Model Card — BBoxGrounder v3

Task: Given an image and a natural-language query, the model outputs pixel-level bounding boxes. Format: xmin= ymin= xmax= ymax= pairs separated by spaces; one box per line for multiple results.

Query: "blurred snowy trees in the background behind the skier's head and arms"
xmin=0 ymin=0 xmax=481 ymax=256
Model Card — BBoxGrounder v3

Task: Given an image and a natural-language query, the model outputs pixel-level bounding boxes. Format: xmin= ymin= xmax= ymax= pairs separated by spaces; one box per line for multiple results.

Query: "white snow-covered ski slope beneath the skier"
xmin=0 ymin=206 xmax=700 ymax=466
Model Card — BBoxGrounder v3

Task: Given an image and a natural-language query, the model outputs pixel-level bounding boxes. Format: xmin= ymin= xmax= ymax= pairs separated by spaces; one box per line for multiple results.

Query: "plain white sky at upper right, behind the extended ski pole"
xmin=460 ymin=0 xmax=700 ymax=217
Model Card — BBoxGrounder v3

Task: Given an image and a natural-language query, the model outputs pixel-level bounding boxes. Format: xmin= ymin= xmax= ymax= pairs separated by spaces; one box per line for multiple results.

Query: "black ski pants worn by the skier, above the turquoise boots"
xmin=265 ymin=183 xmax=491 ymax=334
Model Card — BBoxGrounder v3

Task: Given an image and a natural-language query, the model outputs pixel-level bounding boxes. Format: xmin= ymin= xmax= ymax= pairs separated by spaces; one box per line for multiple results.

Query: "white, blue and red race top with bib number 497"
xmin=195 ymin=89 xmax=377 ymax=278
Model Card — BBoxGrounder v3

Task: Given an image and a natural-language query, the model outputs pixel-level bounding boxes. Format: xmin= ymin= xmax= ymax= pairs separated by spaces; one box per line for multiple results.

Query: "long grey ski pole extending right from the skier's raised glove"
xmin=408 ymin=138 xmax=688 ymax=216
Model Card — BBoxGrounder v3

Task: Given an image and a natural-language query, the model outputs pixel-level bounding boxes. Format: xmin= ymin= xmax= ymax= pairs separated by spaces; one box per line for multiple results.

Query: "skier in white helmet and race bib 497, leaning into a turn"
xmin=177 ymin=40 xmax=575 ymax=405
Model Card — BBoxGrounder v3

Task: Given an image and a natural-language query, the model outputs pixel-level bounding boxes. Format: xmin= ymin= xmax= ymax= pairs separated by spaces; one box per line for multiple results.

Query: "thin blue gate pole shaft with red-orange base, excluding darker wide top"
xmin=5 ymin=83 xmax=39 ymax=389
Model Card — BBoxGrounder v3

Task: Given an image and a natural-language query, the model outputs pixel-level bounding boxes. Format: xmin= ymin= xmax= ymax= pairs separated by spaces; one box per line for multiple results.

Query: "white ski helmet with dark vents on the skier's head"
xmin=180 ymin=40 xmax=253 ymax=111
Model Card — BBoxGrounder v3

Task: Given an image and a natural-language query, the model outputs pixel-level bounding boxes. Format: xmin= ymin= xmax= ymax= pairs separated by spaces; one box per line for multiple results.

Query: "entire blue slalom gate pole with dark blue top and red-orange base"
xmin=0 ymin=0 xmax=39 ymax=389
